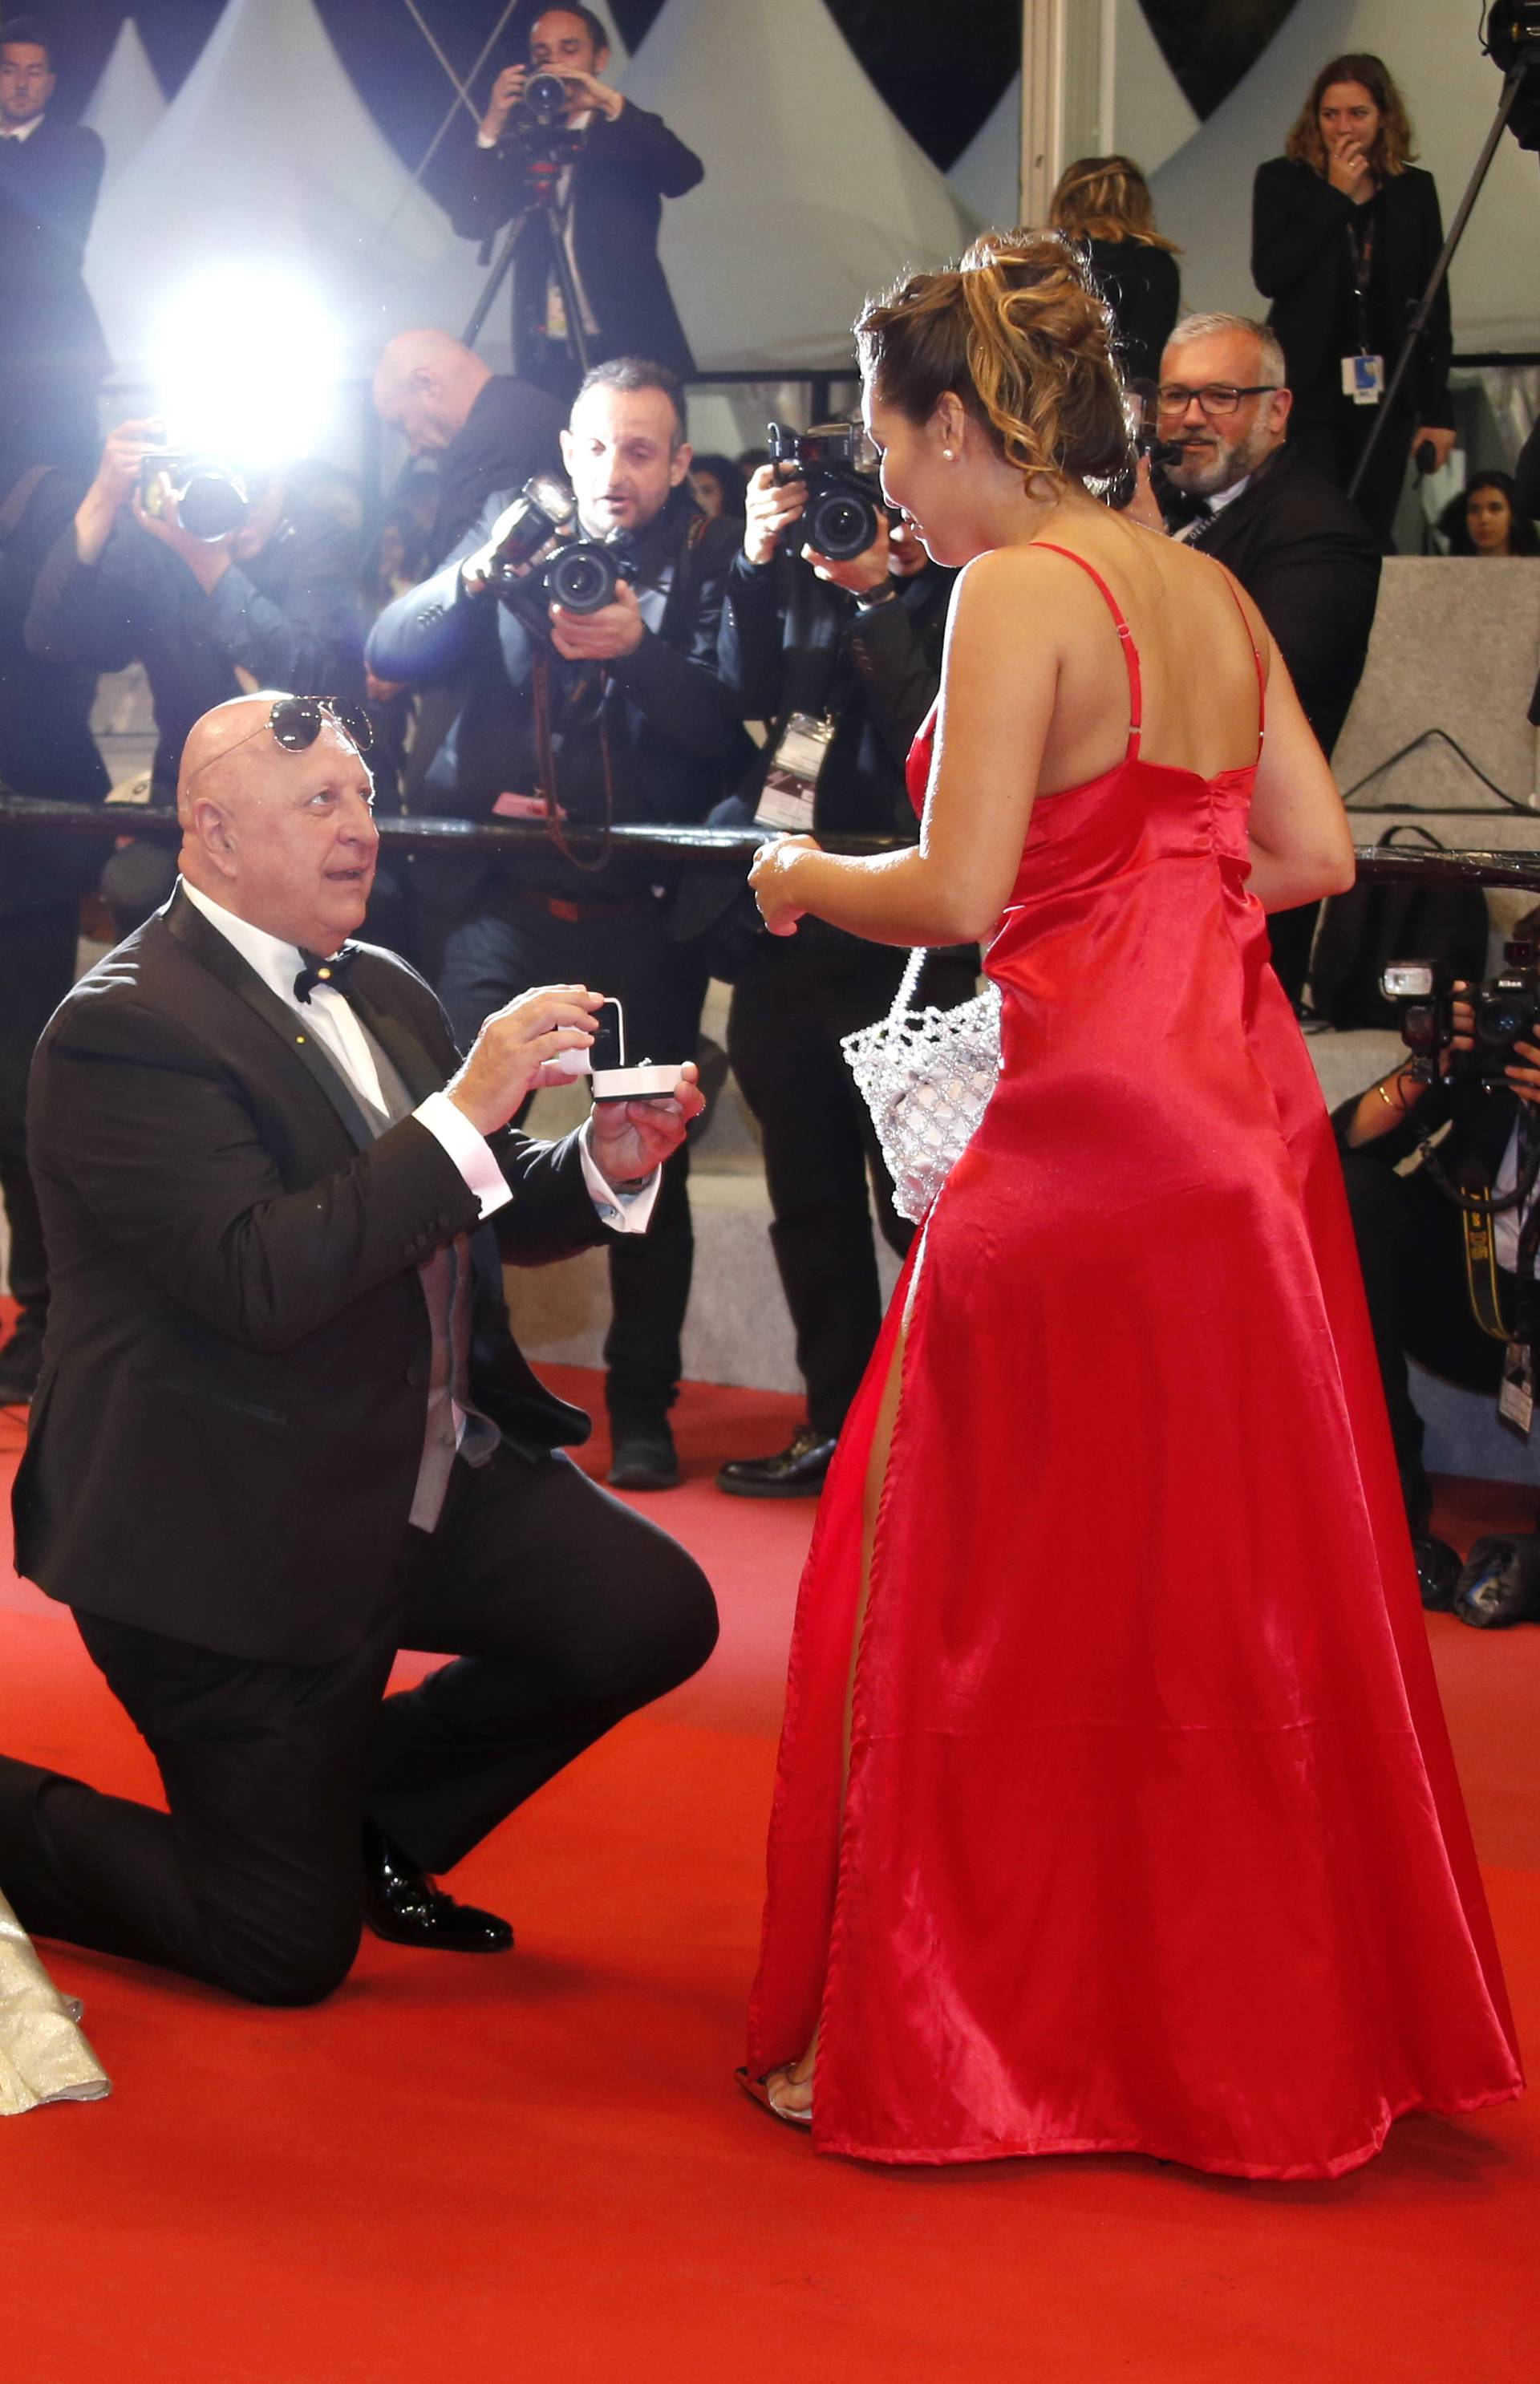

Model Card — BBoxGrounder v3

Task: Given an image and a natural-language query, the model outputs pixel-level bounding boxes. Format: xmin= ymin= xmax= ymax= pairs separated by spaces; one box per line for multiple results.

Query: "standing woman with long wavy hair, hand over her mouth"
xmin=1251 ymin=52 xmax=1454 ymax=551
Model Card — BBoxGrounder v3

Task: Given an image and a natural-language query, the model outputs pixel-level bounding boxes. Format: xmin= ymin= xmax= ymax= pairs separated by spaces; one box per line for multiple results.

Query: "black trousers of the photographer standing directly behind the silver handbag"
xmin=727 ymin=920 xmax=978 ymax=1440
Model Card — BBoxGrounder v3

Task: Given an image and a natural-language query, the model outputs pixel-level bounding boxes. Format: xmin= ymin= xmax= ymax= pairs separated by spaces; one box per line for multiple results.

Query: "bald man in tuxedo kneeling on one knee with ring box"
xmin=0 ymin=694 xmax=715 ymax=2005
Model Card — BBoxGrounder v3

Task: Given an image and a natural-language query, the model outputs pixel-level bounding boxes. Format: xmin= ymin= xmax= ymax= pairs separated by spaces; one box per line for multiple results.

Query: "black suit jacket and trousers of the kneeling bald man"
xmin=0 ymin=894 xmax=715 ymax=2002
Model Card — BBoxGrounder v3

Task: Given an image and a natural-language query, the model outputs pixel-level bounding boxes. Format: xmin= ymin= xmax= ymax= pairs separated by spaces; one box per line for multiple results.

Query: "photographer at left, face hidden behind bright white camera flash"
xmin=26 ymin=420 xmax=365 ymax=801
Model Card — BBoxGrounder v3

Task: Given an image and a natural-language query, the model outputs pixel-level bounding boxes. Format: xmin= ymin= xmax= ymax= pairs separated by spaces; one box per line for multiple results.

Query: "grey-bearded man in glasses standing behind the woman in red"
xmin=1154 ymin=314 xmax=1380 ymax=1003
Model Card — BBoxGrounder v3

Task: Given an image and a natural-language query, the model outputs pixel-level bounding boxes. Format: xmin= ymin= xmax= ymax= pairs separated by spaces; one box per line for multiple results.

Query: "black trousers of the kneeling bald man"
xmin=0 ymin=1449 xmax=718 ymax=2005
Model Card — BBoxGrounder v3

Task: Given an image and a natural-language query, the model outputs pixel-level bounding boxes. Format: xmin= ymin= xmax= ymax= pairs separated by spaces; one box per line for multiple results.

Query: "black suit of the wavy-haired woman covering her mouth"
xmin=1251 ymin=157 xmax=1454 ymax=546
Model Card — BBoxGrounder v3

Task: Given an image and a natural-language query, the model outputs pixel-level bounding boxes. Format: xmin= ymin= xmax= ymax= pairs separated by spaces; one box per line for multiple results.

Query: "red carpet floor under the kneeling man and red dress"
xmin=0 ymin=1376 xmax=1540 ymax=2384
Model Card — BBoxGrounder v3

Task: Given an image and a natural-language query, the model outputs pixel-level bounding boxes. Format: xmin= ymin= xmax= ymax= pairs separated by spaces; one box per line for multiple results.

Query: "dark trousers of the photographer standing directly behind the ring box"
xmin=439 ymin=903 xmax=706 ymax=1425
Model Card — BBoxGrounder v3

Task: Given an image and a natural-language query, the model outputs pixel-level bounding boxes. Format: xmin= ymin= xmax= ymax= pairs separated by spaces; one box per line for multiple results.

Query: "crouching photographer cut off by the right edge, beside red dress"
xmin=1332 ymin=939 xmax=1540 ymax=1612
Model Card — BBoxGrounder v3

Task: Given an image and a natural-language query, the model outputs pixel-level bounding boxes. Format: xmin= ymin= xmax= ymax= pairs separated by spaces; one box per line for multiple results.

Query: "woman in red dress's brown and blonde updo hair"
xmin=856 ymin=231 xmax=1130 ymax=489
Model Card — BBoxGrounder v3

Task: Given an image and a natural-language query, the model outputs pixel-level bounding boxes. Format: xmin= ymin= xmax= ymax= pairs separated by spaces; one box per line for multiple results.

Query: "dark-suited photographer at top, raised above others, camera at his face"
xmin=451 ymin=7 xmax=703 ymax=405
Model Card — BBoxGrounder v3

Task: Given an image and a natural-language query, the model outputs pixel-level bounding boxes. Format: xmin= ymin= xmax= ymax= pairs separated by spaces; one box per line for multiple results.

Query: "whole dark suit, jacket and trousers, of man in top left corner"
xmin=0 ymin=115 xmax=107 ymax=465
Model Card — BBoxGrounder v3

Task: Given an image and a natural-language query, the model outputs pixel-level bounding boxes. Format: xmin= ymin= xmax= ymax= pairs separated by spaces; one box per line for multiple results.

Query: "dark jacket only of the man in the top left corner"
xmin=0 ymin=115 xmax=107 ymax=381
